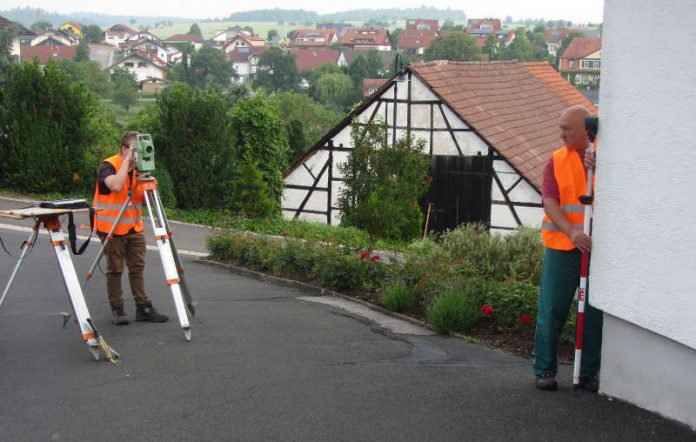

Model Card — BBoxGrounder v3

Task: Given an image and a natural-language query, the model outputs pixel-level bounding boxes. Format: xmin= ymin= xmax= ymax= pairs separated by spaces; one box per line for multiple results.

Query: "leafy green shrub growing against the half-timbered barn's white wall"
xmin=338 ymin=121 xmax=431 ymax=244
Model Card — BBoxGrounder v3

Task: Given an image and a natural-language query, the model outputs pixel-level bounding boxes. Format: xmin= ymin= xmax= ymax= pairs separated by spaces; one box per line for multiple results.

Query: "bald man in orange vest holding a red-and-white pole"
xmin=534 ymin=106 xmax=602 ymax=392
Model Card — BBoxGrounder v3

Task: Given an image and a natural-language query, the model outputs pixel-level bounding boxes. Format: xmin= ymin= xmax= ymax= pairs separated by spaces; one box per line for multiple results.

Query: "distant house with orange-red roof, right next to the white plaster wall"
xmin=558 ymin=37 xmax=602 ymax=88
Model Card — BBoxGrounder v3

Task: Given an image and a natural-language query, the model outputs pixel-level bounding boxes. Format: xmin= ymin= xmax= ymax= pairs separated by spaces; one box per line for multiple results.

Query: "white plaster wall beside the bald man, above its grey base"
xmin=590 ymin=0 xmax=696 ymax=349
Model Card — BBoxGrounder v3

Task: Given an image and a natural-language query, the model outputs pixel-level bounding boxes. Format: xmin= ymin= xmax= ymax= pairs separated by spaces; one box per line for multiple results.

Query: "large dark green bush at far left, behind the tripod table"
xmin=0 ymin=61 xmax=97 ymax=193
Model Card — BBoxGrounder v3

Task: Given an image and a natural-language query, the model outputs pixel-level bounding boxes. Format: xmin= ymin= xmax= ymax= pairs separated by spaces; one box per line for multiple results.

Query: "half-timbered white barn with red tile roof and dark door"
xmin=282 ymin=60 xmax=596 ymax=233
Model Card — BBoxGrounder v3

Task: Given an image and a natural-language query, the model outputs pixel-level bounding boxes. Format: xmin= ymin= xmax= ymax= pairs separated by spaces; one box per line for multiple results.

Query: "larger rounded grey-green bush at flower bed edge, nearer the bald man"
xmin=426 ymin=290 xmax=481 ymax=334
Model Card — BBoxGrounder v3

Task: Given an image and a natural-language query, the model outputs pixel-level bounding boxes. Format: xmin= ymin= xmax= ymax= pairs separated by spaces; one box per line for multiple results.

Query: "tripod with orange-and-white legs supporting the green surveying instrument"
xmin=85 ymin=175 xmax=196 ymax=341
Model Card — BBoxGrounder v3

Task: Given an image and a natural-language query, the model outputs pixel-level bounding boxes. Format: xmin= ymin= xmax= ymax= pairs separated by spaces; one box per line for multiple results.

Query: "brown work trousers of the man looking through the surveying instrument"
xmin=101 ymin=231 xmax=147 ymax=304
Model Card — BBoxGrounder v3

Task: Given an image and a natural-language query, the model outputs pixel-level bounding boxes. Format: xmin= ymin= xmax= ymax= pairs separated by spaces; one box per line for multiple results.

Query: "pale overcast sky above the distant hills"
xmin=0 ymin=0 xmax=604 ymax=23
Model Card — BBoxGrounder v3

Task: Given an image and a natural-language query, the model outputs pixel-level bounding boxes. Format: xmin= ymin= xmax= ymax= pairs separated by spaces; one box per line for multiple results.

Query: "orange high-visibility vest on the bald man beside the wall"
xmin=541 ymin=146 xmax=587 ymax=250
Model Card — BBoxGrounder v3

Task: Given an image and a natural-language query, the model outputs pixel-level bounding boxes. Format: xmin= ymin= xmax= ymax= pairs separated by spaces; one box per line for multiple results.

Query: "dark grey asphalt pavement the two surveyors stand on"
xmin=0 ymin=201 xmax=696 ymax=441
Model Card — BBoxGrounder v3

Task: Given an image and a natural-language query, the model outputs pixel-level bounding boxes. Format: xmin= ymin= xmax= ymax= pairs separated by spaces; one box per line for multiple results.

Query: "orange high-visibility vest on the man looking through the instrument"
xmin=94 ymin=155 xmax=144 ymax=235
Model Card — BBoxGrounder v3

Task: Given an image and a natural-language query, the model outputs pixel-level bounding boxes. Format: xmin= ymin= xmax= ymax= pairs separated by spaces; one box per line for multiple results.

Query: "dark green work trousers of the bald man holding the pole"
xmin=534 ymin=247 xmax=602 ymax=376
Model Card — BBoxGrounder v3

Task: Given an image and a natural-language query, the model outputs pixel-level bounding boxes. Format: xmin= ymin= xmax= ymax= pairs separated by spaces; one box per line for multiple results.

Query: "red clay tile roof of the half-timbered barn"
xmin=409 ymin=60 xmax=597 ymax=191
